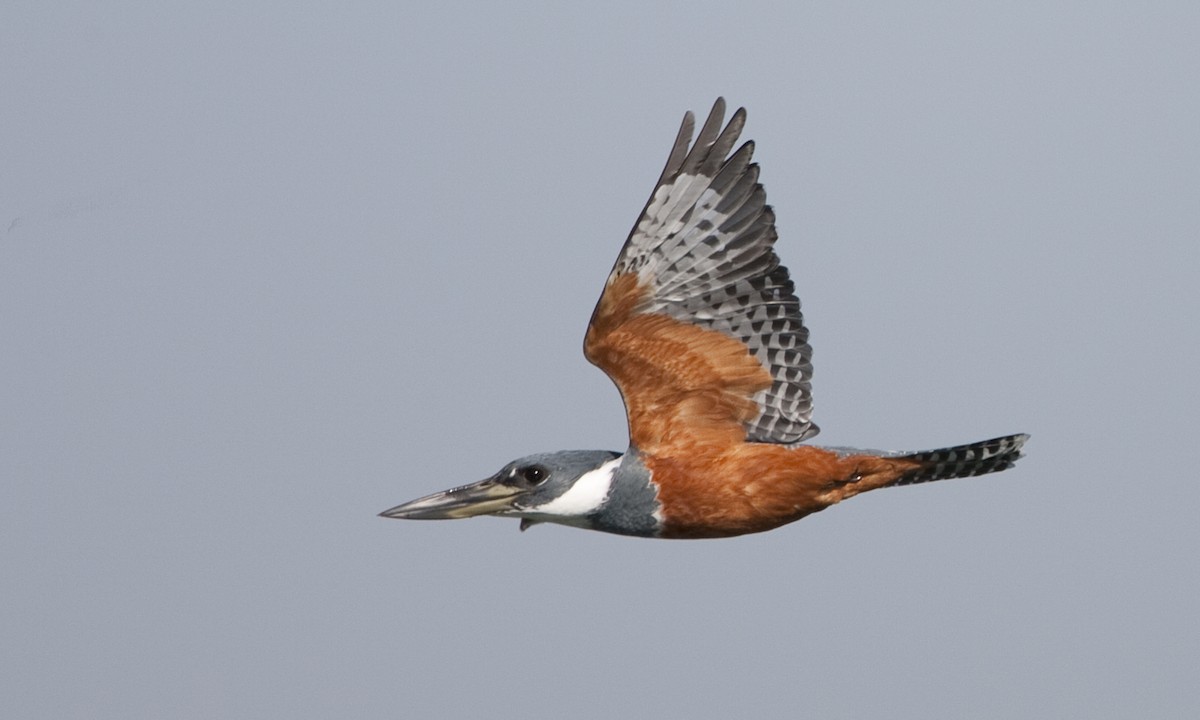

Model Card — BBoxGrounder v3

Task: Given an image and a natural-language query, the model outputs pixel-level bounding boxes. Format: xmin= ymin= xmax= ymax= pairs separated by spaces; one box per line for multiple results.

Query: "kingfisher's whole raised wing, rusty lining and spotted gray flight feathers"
xmin=583 ymin=98 xmax=817 ymax=451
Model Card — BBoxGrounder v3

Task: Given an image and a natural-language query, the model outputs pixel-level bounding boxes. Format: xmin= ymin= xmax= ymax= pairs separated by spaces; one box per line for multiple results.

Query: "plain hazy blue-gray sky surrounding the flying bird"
xmin=0 ymin=2 xmax=1200 ymax=720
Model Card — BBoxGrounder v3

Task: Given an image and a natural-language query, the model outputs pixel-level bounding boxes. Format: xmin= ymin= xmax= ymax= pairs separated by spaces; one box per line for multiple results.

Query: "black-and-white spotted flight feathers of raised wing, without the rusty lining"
xmin=608 ymin=100 xmax=817 ymax=443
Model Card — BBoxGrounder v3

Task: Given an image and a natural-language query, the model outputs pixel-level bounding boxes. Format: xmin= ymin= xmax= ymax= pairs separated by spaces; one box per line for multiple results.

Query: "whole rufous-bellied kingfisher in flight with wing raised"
xmin=380 ymin=98 xmax=1028 ymax=538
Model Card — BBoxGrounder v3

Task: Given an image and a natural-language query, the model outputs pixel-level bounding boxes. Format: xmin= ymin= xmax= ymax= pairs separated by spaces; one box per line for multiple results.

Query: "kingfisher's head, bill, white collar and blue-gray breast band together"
xmin=380 ymin=450 xmax=656 ymax=535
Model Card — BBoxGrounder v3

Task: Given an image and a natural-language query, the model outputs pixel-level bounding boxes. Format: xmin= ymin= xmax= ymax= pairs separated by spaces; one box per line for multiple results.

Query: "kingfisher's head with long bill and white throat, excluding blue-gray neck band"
xmin=379 ymin=450 xmax=622 ymax=529
